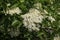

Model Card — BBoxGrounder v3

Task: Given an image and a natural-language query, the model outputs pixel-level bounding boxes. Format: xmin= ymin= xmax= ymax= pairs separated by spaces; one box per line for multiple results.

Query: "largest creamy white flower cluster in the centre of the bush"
xmin=21 ymin=8 xmax=44 ymax=31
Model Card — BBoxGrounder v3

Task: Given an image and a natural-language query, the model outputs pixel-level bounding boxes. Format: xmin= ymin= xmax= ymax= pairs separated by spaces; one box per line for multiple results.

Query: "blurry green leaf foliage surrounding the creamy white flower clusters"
xmin=0 ymin=0 xmax=60 ymax=40
